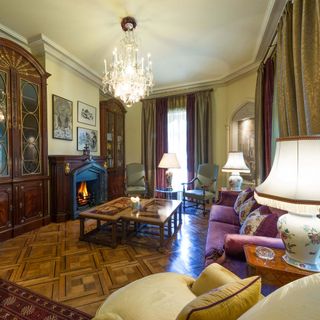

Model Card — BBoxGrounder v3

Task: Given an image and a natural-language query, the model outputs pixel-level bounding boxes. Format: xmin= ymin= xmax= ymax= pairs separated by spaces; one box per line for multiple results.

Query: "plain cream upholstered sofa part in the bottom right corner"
xmin=239 ymin=273 xmax=320 ymax=320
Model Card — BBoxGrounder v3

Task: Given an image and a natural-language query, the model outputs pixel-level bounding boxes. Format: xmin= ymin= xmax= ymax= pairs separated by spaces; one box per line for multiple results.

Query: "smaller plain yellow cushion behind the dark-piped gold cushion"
xmin=191 ymin=263 xmax=240 ymax=296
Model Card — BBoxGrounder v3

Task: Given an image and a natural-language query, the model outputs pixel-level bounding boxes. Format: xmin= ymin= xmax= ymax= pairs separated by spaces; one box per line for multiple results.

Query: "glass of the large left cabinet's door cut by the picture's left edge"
xmin=0 ymin=71 xmax=9 ymax=177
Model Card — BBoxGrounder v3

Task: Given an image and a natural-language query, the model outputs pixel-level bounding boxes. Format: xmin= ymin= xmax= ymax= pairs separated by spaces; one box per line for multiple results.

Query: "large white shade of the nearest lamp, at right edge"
xmin=255 ymin=136 xmax=320 ymax=215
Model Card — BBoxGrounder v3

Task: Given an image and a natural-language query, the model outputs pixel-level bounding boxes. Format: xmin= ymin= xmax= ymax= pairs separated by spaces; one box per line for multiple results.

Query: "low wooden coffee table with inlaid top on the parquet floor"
xmin=79 ymin=197 xmax=182 ymax=251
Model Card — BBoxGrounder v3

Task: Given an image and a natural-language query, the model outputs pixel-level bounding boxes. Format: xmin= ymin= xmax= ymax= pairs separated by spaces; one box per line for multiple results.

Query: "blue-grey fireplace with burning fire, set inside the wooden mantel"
xmin=70 ymin=162 xmax=107 ymax=219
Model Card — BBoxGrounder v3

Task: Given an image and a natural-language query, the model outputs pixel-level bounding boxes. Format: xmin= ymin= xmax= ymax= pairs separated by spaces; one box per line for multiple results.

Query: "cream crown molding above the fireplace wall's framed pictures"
xmin=28 ymin=34 xmax=101 ymax=88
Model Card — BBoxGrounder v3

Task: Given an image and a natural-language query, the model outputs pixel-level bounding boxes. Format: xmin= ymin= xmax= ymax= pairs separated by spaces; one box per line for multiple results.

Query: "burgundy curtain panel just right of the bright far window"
xmin=187 ymin=94 xmax=195 ymax=181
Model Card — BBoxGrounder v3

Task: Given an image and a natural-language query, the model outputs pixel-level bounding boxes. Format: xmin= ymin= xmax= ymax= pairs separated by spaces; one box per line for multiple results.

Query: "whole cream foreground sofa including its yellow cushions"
xmin=93 ymin=263 xmax=320 ymax=320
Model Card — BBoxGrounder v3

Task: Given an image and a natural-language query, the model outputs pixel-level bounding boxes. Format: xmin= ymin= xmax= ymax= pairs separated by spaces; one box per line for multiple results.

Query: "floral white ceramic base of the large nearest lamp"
xmin=278 ymin=212 xmax=320 ymax=272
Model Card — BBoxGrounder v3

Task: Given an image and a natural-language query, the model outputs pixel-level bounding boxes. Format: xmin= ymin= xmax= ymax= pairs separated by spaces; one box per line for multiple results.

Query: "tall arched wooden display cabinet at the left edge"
xmin=0 ymin=38 xmax=50 ymax=240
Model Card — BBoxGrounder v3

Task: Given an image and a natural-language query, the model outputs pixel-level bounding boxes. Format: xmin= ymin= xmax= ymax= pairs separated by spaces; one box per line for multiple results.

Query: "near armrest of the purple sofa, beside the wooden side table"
xmin=224 ymin=234 xmax=285 ymax=257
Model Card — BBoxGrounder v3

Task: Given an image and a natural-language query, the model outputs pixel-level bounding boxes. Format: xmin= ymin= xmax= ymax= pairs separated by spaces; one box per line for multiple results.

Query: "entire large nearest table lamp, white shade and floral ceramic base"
xmin=255 ymin=136 xmax=320 ymax=271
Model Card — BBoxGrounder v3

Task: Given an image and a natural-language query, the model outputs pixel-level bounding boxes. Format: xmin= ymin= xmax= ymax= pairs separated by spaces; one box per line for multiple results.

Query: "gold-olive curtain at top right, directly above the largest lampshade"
xmin=277 ymin=0 xmax=320 ymax=137
